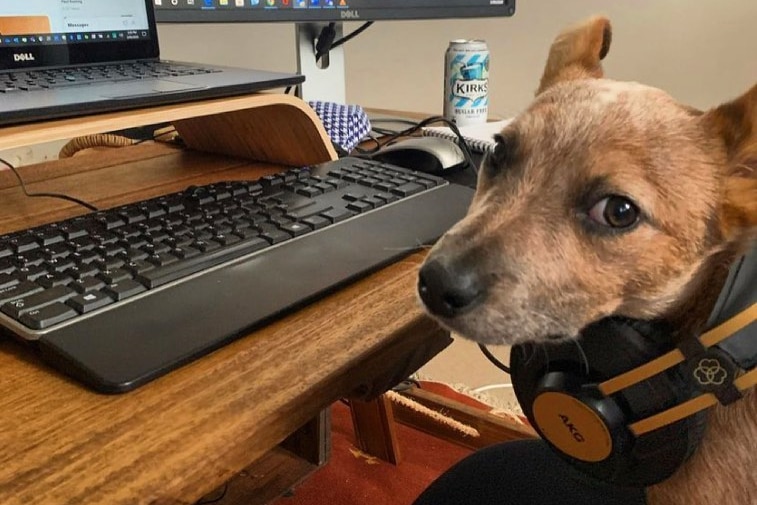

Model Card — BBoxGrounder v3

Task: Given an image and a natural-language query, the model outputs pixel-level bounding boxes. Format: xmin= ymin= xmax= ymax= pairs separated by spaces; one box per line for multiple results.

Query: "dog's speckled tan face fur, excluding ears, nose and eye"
xmin=426 ymin=80 xmax=722 ymax=343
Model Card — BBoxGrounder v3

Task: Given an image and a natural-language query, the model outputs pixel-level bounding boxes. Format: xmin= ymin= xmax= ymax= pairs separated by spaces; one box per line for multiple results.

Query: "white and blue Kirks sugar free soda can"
xmin=444 ymin=40 xmax=489 ymax=126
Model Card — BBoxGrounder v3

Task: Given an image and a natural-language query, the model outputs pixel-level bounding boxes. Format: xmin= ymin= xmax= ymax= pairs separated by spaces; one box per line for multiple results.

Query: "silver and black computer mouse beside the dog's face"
xmin=372 ymin=137 xmax=467 ymax=175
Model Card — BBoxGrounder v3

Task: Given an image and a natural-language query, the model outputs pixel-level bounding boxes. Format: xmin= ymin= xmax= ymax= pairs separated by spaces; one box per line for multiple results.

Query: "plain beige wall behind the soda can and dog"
xmin=160 ymin=0 xmax=757 ymax=116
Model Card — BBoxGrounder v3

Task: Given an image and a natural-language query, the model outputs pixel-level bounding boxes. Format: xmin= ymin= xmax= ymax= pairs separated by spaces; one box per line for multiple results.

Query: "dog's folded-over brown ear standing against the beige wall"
xmin=536 ymin=16 xmax=612 ymax=95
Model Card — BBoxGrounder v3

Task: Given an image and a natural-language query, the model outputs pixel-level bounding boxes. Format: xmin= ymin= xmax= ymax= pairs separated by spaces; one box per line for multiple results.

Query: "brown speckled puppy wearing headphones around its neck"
xmin=419 ymin=17 xmax=757 ymax=505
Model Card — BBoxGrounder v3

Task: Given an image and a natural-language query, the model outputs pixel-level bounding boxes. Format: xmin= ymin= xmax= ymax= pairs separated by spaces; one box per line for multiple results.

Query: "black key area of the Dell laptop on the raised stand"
xmin=0 ymin=61 xmax=219 ymax=93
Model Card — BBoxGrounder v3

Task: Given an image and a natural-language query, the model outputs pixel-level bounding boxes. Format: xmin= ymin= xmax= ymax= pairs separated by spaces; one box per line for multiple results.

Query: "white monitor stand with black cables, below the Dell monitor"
xmin=295 ymin=23 xmax=347 ymax=104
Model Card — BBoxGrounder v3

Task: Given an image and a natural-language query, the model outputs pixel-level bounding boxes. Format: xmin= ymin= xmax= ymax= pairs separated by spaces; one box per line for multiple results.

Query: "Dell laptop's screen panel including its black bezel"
xmin=0 ymin=0 xmax=158 ymax=69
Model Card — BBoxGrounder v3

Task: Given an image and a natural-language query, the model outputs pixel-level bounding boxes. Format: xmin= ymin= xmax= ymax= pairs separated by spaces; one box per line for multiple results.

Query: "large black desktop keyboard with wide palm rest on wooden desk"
xmin=0 ymin=158 xmax=473 ymax=393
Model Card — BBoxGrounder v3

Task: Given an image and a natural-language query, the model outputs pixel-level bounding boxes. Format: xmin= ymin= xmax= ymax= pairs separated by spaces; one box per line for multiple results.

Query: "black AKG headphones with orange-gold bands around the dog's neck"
xmin=510 ymin=242 xmax=757 ymax=486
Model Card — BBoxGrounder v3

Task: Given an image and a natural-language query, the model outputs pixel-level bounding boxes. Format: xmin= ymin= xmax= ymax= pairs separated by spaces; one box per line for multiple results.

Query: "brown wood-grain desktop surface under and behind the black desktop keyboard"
xmin=0 ymin=139 xmax=448 ymax=505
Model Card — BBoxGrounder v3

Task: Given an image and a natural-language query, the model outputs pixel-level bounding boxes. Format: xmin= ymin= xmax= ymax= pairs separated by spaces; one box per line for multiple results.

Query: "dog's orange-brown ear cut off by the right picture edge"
xmin=702 ymin=85 xmax=757 ymax=243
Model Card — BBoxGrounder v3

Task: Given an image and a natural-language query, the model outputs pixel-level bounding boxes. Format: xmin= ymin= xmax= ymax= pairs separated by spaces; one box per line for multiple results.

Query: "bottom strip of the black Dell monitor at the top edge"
xmin=153 ymin=0 xmax=515 ymax=22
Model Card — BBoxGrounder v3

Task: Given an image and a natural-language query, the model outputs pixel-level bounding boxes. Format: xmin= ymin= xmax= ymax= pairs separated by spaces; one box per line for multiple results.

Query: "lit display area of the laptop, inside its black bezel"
xmin=0 ymin=0 xmax=150 ymax=46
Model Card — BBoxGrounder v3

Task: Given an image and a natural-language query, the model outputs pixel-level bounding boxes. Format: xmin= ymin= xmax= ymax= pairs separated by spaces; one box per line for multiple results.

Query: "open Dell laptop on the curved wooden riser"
xmin=0 ymin=0 xmax=305 ymax=125
